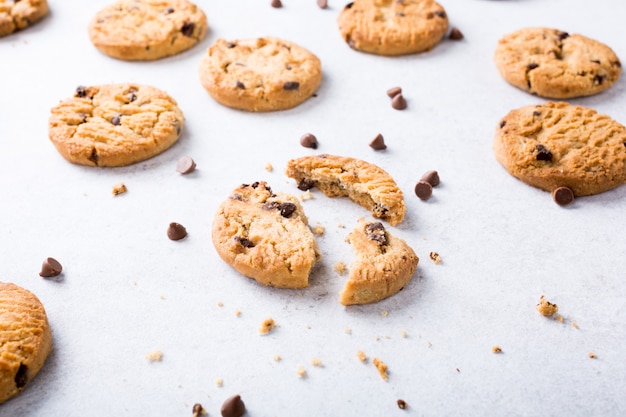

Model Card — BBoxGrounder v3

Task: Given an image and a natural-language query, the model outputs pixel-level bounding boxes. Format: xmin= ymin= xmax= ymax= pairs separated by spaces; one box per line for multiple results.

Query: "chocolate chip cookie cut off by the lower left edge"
xmin=0 ymin=282 xmax=52 ymax=403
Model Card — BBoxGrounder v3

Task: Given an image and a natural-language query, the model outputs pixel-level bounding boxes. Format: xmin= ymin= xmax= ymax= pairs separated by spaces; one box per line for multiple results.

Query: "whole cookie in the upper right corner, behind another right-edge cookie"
xmin=494 ymin=28 xmax=622 ymax=99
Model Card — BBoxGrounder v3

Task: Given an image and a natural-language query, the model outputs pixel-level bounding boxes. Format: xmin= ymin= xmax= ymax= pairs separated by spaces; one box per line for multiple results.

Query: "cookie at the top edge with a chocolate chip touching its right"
xmin=337 ymin=0 xmax=448 ymax=56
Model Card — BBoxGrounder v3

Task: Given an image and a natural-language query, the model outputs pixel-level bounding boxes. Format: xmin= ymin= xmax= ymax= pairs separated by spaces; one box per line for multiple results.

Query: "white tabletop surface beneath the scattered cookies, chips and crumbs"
xmin=0 ymin=0 xmax=626 ymax=417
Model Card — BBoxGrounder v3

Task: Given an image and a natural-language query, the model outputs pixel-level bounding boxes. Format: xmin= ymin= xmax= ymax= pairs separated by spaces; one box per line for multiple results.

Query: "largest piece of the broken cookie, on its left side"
xmin=212 ymin=182 xmax=321 ymax=288
